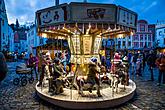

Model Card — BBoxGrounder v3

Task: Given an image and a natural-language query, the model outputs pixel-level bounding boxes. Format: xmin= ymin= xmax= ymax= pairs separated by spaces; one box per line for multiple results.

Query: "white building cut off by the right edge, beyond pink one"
xmin=156 ymin=22 xmax=165 ymax=48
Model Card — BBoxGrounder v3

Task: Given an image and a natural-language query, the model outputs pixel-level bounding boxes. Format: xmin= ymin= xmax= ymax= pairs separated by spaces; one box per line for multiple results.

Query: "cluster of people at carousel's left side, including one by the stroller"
xmin=27 ymin=51 xmax=69 ymax=86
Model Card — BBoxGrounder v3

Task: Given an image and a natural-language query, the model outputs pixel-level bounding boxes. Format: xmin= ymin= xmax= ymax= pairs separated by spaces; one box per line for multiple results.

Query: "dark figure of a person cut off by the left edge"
xmin=0 ymin=52 xmax=8 ymax=82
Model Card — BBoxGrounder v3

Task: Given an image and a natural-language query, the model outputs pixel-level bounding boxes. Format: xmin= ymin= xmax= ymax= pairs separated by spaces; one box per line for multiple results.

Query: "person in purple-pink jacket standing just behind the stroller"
xmin=28 ymin=53 xmax=39 ymax=80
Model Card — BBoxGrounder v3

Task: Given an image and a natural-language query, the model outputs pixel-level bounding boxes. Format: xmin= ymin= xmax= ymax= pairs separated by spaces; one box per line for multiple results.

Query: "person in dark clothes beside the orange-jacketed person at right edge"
xmin=147 ymin=50 xmax=156 ymax=81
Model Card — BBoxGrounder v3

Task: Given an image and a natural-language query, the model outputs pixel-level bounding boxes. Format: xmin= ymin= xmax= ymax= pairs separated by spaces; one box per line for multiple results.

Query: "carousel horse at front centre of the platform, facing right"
xmin=76 ymin=63 xmax=102 ymax=97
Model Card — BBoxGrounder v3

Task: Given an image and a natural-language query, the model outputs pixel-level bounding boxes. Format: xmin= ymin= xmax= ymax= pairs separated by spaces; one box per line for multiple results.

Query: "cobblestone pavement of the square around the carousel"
xmin=0 ymin=62 xmax=165 ymax=110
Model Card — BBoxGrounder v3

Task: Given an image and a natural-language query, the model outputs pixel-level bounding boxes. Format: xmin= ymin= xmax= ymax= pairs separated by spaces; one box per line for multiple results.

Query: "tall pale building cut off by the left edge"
xmin=0 ymin=0 xmax=8 ymax=51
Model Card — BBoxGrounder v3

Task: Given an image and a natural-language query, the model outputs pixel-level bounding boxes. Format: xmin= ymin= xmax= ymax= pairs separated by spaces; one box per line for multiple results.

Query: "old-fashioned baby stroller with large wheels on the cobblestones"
xmin=13 ymin=63 xmax=34 ymax=86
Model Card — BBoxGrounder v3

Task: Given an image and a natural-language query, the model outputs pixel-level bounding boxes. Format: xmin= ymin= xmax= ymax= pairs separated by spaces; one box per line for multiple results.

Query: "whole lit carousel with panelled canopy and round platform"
xmin=36 ymin=2 xmax=137 ymax=109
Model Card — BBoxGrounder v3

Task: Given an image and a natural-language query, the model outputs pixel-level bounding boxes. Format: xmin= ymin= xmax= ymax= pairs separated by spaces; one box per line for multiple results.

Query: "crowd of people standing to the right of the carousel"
xmin=101 ymin=50 xmax=165 ymax=85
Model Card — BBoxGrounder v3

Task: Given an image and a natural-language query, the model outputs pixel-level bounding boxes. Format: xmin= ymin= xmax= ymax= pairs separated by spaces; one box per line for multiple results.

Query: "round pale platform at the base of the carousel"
xmin=36 ymin=80 xmax=136 ymax=109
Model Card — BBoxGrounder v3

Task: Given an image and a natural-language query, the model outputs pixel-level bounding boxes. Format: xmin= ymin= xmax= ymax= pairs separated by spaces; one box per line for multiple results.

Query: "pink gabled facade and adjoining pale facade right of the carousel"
xmin=115 ymin=20 xmax=155 ymax=50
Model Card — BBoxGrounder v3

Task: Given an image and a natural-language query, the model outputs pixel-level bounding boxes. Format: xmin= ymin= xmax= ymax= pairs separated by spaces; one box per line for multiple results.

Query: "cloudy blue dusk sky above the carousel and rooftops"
xmin=5 ymin=0 xmax=165 ymax=24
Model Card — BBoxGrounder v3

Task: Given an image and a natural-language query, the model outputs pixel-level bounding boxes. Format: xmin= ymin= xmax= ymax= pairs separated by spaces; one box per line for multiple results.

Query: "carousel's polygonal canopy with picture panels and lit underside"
xmin=36 ymin=2 xmax=137 ymax=38
